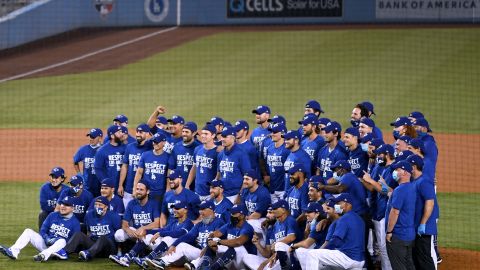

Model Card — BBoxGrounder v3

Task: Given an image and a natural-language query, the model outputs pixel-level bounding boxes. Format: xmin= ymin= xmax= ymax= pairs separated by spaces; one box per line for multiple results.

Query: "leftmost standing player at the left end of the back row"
xmin=73 ymin=128 xmax=103 ymax=196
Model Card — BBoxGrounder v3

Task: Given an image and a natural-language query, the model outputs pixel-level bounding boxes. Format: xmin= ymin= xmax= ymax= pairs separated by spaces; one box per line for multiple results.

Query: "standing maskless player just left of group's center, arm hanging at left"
xmin=185 ymin=125 xmax=217 ymax=201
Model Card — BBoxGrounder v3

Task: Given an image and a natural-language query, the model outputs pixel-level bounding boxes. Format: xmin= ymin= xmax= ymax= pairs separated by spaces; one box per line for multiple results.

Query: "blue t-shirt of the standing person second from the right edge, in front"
xmin=385 ymin=182 xmax=417 ymax=241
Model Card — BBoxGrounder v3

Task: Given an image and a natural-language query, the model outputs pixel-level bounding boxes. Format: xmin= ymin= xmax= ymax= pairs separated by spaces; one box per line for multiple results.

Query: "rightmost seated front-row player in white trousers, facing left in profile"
xmin=307 ymin=193 xmax=366 ymax=269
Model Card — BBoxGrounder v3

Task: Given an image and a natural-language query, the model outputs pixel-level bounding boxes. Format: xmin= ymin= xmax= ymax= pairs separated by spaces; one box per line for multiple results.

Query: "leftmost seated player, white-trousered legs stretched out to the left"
xmin=0 ymin=197 xmax=80 ymax=262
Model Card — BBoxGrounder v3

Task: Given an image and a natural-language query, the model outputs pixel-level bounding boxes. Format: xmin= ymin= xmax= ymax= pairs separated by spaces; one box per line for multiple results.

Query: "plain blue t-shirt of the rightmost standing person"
xmin=413 ymin=175 xmax=440 ymax=235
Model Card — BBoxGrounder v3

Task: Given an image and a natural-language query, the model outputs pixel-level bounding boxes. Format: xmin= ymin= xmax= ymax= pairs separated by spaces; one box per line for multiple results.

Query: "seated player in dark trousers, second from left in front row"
xmin=65 ymin=196 xmax=121 ymax=261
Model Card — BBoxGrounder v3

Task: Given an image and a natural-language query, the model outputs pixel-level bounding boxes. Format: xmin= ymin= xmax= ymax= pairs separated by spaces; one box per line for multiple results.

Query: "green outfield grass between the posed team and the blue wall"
xmin=0 ymin=28 xmax=480 ymax=133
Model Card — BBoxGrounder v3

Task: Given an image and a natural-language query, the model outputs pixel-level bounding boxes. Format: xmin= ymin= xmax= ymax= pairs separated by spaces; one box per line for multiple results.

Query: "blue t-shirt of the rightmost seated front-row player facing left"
xmin=333 ymin=211 xmax=365 ymax=262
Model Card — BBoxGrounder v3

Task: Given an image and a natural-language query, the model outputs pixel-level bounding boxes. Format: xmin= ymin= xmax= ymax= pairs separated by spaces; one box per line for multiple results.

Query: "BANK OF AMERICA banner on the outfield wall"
xmin=376 ymin=0 xmax=480 ymax=19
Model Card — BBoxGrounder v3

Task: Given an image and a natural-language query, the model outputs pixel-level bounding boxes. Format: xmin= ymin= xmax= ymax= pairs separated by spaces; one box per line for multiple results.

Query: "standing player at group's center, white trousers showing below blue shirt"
xmin=216 ymin=127 xmax=251 ymax=202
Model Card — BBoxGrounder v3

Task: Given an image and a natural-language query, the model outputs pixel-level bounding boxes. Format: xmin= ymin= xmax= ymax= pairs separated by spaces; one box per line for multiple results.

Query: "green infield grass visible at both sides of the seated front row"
xmin=0 ymin=182 xmax=480 ymax=269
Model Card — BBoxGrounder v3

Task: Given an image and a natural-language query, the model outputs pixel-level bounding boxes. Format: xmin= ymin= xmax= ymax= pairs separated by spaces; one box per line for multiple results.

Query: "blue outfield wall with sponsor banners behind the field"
xmin=0 ymin=0 xmax=480 ymax=49
